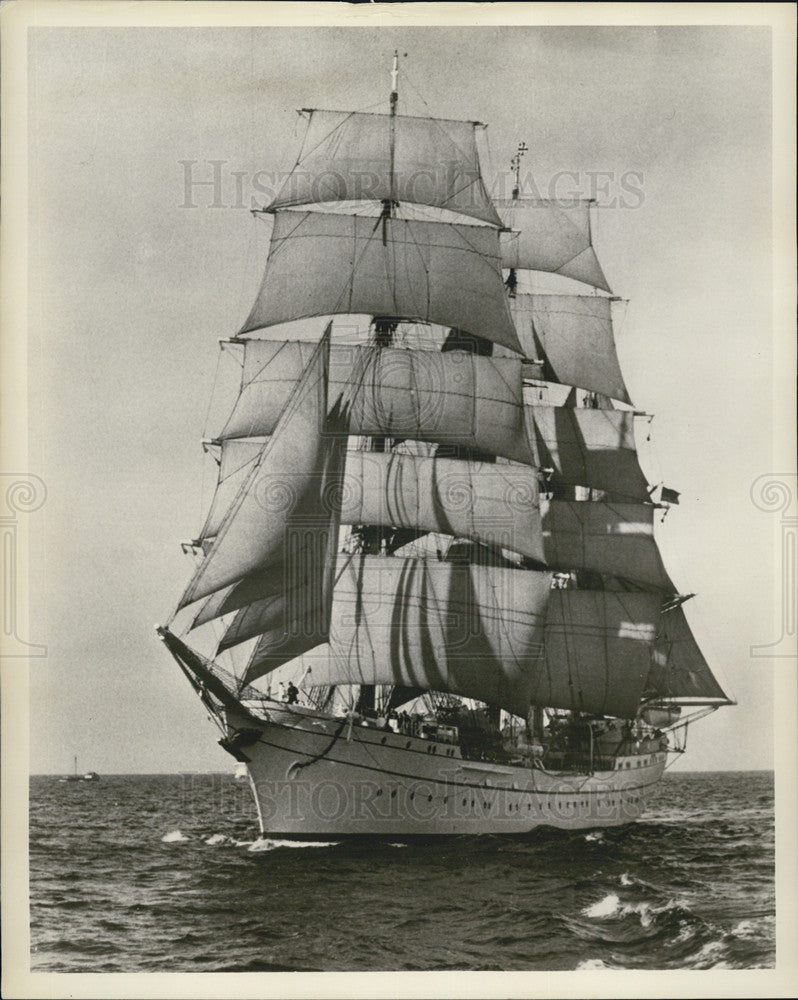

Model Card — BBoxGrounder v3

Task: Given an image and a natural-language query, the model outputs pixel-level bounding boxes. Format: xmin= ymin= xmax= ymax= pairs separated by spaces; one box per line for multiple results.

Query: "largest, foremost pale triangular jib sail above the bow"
xmin=179 ymin=327 xmax=345 ymax=608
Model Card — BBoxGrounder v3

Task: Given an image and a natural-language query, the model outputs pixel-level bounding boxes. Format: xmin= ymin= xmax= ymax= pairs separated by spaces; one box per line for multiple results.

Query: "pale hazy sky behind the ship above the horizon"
xmin=21 ymin=26 xmax=789 ymax=773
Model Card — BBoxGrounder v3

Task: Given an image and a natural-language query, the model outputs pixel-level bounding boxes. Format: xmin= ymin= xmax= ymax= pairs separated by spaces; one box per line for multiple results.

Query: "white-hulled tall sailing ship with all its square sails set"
xmin=158 ymin=57 xmax=731 ymax=838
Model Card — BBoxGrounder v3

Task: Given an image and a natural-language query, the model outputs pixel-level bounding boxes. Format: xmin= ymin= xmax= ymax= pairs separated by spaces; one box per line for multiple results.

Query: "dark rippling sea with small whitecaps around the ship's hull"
xmin=30 ymin=772 xmax=775 ymax=972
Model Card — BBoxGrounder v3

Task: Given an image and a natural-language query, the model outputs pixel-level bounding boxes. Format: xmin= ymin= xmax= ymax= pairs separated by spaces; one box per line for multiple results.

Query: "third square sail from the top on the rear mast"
xmin=526 ymin=406 xmax=648 ymax=500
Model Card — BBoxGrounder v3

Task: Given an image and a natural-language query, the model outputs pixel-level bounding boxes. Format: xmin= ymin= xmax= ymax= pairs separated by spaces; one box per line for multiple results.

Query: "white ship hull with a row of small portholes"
xmin=228 ymin=705 xmax=667 ymax=839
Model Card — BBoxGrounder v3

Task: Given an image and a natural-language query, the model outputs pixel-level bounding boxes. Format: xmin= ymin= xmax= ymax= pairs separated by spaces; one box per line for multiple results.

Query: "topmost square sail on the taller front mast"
xmin=269 ymin=110 xmax=501 ymax=226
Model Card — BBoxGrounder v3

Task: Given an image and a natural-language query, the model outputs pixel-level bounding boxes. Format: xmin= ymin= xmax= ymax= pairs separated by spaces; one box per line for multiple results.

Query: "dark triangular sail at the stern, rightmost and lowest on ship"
xmin=646 ymin=606 xmax=731 ymax=703
